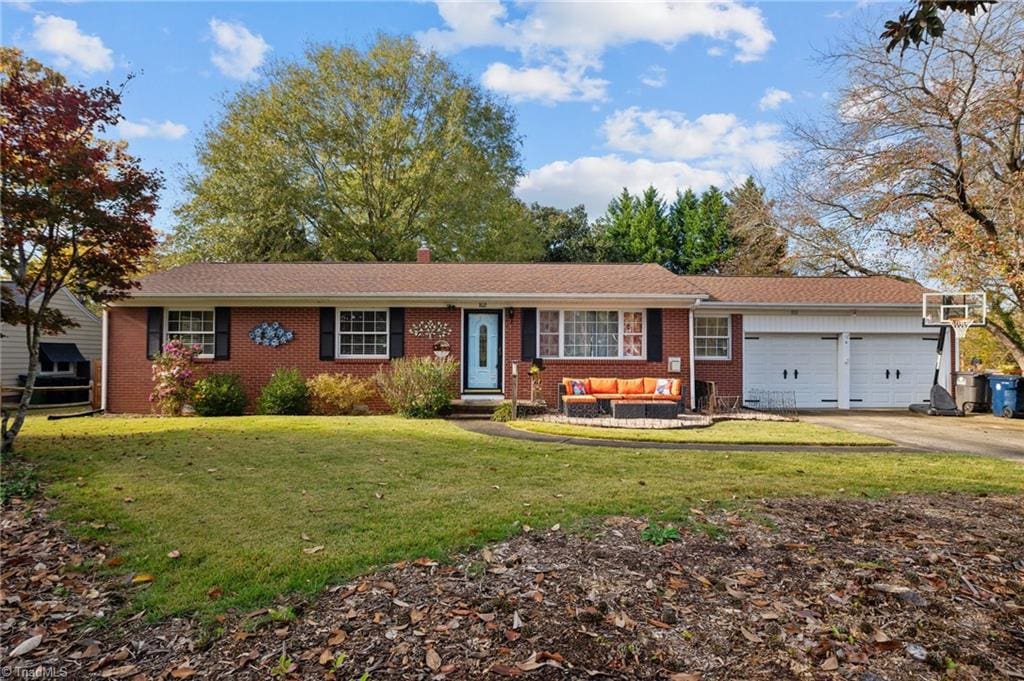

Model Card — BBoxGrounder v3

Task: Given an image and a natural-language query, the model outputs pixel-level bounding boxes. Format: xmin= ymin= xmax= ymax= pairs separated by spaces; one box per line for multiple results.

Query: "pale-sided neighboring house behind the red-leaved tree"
xmin=0 ymin=282 xmax=102 ymax=394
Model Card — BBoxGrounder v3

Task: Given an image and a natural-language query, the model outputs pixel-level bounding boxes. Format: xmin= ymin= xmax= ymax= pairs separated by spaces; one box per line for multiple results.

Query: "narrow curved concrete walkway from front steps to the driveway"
xmin=453 ymin=419 xmax=925 ymax=454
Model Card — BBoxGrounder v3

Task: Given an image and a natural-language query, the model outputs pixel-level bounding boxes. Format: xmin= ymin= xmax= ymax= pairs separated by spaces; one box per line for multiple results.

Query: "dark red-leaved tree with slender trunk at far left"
xmin=0 ymin=48 xmax=160 ymax=452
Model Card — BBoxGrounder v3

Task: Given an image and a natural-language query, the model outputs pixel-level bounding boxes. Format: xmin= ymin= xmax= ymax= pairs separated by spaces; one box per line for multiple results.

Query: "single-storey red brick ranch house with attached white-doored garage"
xmin=102 ymin=249 xmax=955 ymax=413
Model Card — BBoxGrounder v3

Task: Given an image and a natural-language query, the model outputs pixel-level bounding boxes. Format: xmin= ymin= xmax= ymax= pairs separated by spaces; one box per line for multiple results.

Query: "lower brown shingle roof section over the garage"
xmin=680 ymin=276 xmax=928 ymax=305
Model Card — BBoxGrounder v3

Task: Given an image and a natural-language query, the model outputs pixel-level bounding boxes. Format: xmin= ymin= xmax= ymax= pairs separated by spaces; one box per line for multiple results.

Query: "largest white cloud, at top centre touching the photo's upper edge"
xmin=417 ymin=0 xmax=775 ymax=101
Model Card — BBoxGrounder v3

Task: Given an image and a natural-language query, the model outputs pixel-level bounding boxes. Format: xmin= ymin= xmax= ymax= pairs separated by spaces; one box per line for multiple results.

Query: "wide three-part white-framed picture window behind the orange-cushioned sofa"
xmin=537 ymin=309 xmax=646 ymax=359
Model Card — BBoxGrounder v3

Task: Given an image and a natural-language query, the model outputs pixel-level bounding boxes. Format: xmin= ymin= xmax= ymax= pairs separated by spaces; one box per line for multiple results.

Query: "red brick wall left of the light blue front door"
xmin=106 ymin=307 xmax=462 ymax=413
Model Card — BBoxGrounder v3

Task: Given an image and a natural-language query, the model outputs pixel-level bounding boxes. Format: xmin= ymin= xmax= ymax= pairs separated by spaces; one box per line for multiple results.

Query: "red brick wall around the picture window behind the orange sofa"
xmin=505 ymin=308 xmax=690 ymax=409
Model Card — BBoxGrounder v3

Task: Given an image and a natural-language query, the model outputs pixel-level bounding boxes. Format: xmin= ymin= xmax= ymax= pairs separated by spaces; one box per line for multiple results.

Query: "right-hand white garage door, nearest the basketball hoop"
xmin=850 ymin=334 xmax=937 ymax=409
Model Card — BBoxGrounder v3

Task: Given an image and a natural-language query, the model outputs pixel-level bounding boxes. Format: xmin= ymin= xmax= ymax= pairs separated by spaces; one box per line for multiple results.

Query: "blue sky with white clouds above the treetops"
xmin=0 ymin=0 xmax=902 ymax=228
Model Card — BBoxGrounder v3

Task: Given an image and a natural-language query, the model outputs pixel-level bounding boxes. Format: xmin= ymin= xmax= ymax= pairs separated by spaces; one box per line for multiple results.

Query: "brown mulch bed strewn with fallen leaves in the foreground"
xmin=0 ymin=495 xmax=1024 ymax=681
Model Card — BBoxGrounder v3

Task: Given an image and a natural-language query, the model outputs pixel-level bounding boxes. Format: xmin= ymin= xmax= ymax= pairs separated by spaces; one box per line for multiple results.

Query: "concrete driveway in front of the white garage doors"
xmin=800 ymin=410 xmax=1024 ymax=463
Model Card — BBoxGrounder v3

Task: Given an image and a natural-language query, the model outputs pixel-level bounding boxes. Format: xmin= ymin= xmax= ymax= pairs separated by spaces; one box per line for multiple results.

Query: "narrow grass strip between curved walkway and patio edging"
xmin=509 ymin=421 xmax=892 ymax=446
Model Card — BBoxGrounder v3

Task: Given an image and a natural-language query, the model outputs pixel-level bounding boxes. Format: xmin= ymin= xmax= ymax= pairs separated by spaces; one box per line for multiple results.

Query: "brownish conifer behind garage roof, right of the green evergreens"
xmin=721 ymin=177 xmax=790 ymax=276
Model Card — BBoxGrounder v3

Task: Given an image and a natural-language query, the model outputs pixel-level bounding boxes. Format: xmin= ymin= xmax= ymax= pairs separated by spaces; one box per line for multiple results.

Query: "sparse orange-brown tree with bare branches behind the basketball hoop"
xmin=783 ymin=2 xmax=1024 ymax=367
